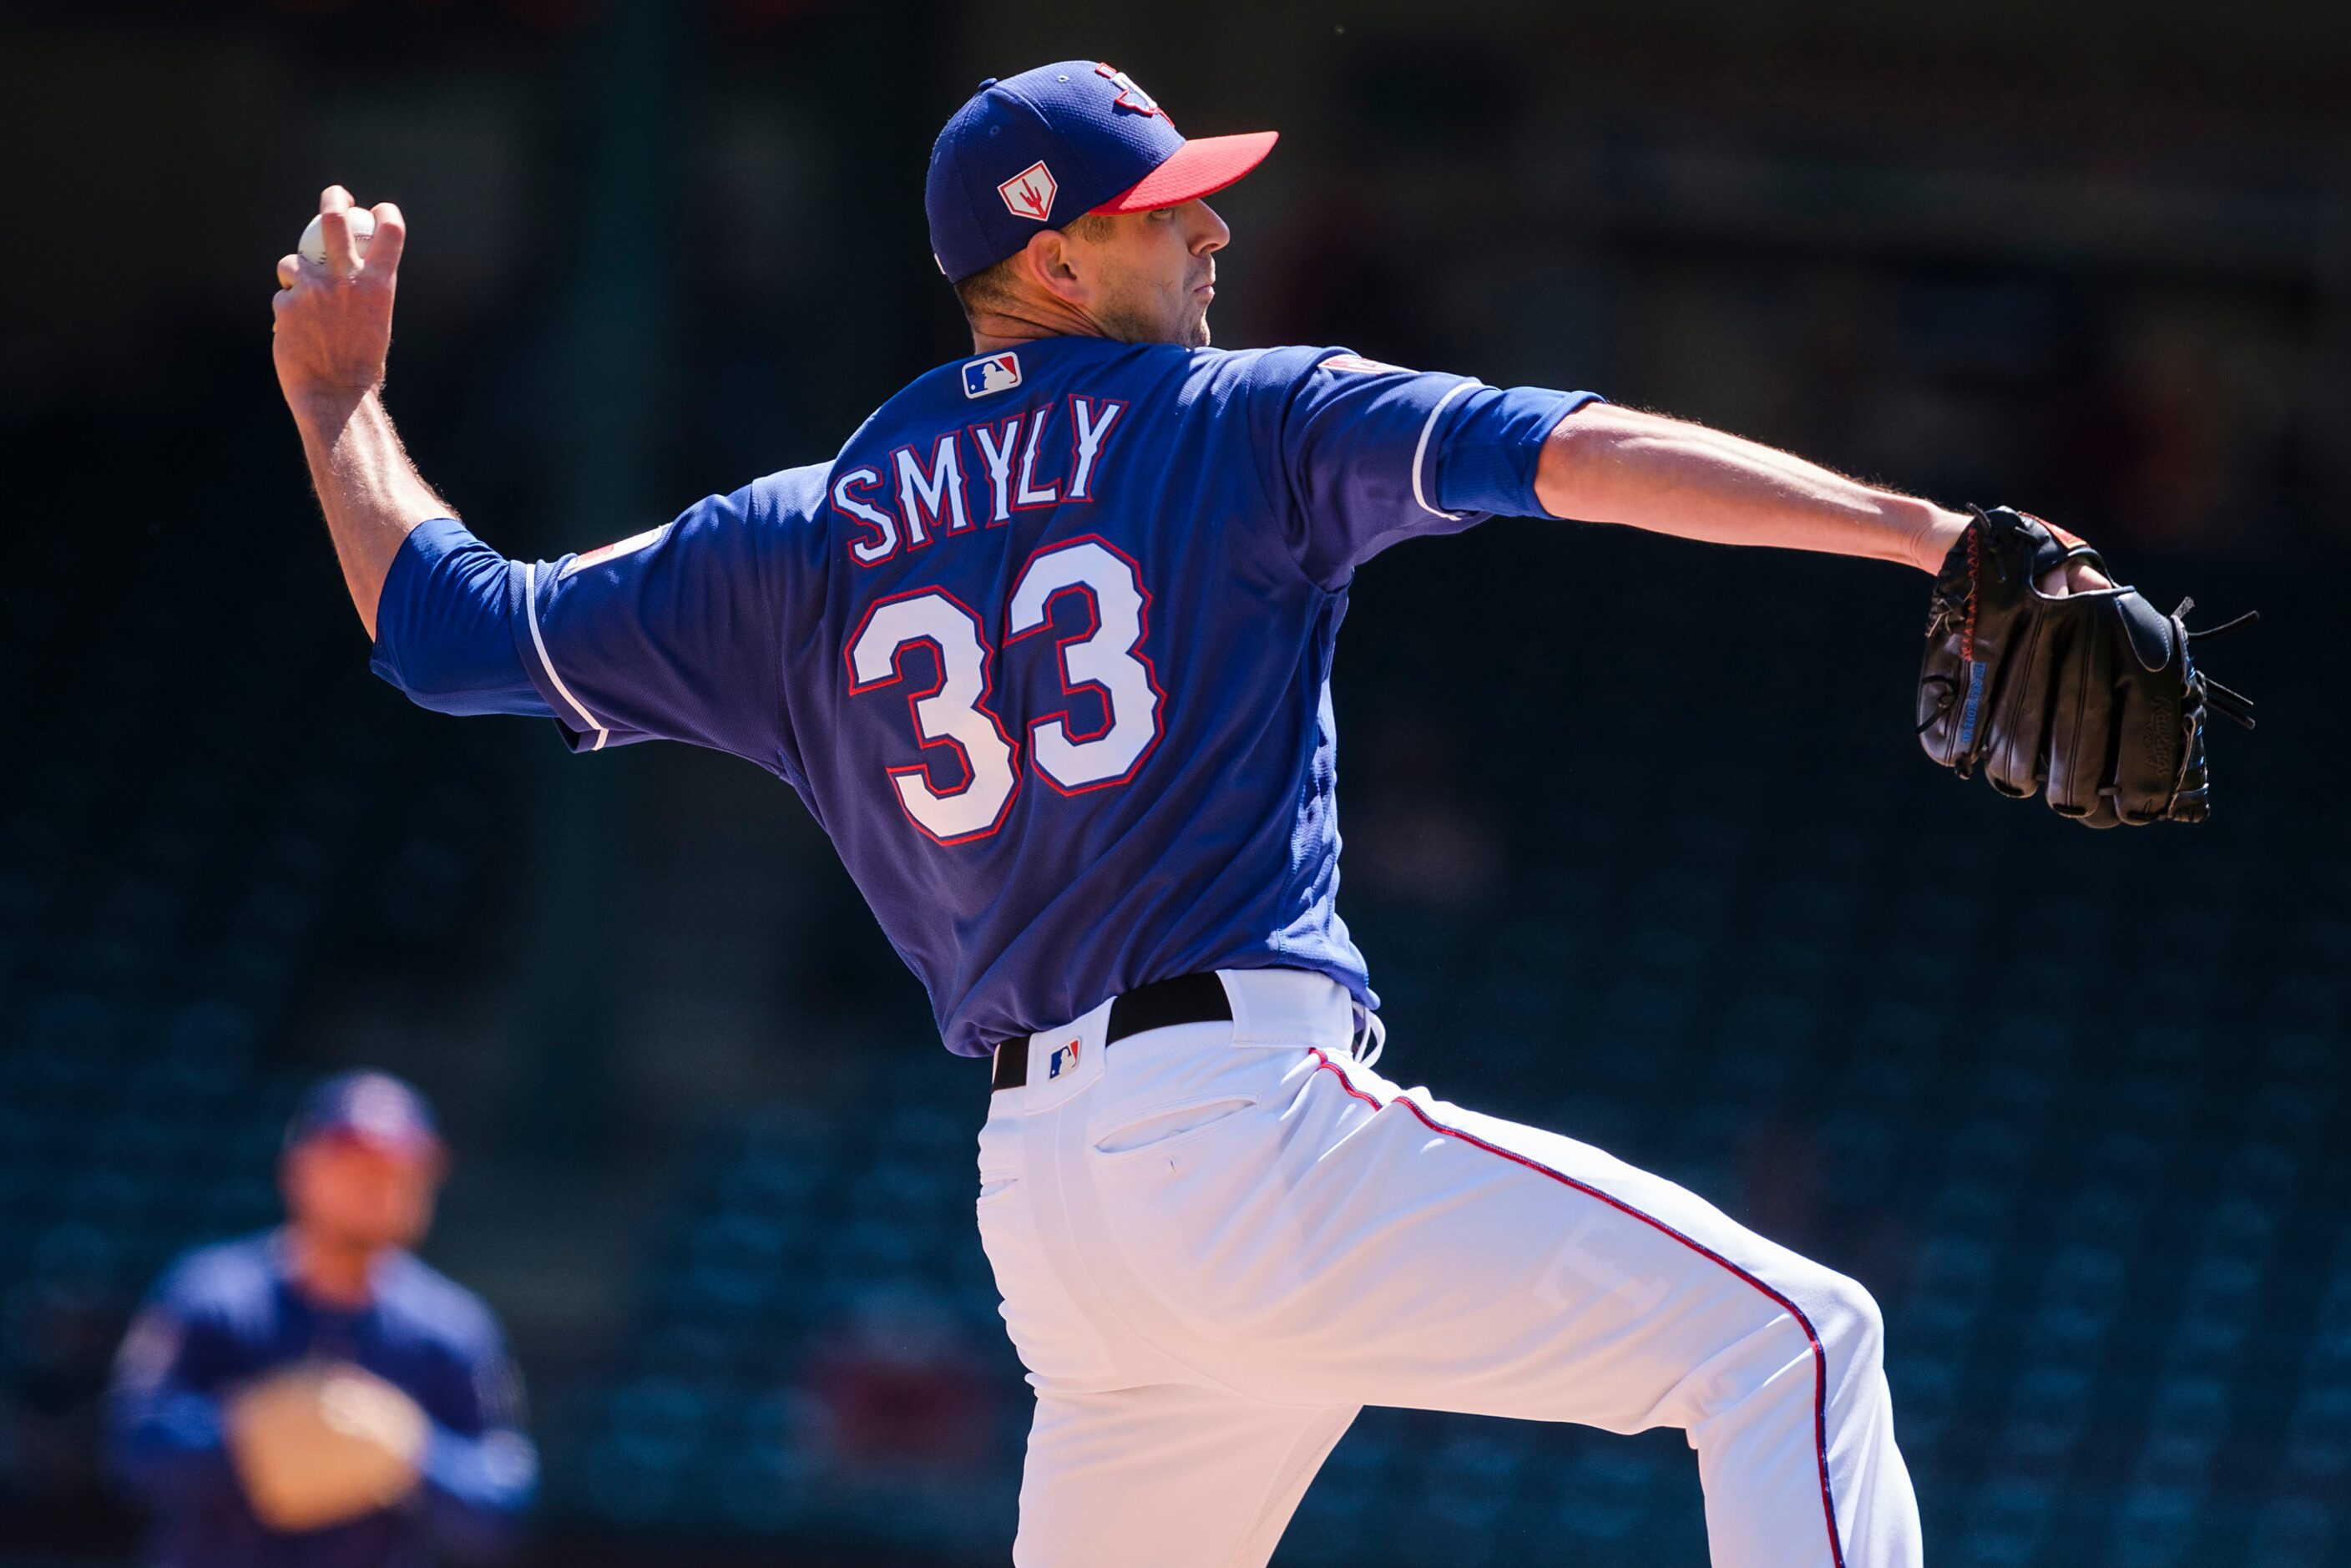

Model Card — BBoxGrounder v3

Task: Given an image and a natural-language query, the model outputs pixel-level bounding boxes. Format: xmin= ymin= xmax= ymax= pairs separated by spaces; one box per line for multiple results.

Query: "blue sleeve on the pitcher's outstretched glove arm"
xmin=1251 ymin=348 xmax=1594 ymax=588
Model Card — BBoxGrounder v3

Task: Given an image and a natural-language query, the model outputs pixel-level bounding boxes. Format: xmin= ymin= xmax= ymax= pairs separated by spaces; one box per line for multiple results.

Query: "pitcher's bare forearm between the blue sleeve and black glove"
xmin=1535 ymin=404 xmax=1968 ymax=571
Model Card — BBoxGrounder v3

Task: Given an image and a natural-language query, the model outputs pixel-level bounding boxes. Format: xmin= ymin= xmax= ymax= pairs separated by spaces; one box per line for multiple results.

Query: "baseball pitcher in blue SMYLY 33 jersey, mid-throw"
xmin=277 ymin=61 xmax=2247 ymax=1568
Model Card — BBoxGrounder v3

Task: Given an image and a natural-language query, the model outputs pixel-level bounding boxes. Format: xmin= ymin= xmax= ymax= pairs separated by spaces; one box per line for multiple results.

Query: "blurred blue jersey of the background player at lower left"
xmin=106 ymin=1232 xmax=538 ymax=1568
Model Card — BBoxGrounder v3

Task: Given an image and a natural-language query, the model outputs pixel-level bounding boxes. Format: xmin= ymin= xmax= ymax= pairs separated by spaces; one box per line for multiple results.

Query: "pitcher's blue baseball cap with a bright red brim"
xmin=922 ymin=58 xmax=1279 ymax=282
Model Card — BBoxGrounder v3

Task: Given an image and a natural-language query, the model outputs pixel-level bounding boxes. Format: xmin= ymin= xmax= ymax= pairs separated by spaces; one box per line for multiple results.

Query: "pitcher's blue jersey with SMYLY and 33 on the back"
xmin=377 ymin=338 xmax=1590 ymax=1055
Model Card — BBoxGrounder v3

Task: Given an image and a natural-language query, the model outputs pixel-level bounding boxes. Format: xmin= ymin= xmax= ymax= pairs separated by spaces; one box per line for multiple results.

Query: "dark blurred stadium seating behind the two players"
xmin=0 ymin=0 xmax=2351 ymax=1568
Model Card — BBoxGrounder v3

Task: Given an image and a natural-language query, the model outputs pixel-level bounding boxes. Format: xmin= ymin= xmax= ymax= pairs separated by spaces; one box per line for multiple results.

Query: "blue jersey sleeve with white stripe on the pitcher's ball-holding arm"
xmin=508 ymin=470 xmax=823 ymax=776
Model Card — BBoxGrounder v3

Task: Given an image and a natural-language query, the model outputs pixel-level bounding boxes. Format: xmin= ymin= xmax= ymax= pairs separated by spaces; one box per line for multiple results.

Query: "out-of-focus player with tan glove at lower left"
xmin=106 ymin=1072 xmax=538 ymax=1568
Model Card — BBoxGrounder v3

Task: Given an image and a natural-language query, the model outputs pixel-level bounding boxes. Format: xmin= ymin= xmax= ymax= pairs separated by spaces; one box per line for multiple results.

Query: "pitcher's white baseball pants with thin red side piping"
xmin=978 ymin=971 xmax=1921 ymax=1568
